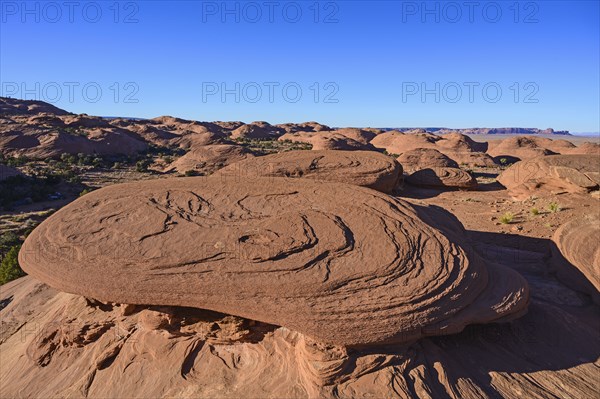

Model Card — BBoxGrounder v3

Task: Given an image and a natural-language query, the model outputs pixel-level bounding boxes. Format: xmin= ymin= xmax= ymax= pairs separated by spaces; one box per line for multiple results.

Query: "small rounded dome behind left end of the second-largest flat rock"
xmin=166 ymin=144 xmax=254 ymax=173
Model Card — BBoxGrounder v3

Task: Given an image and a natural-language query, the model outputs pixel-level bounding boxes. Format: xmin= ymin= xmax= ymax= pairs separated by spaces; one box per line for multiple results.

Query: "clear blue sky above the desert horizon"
xmin=0 ymin=0 xmax=600 ymax=132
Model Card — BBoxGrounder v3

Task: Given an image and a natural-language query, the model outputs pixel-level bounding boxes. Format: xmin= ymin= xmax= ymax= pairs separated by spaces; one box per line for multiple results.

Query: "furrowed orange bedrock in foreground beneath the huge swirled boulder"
xmin=0 ymin=277 xmax=600 ymax=399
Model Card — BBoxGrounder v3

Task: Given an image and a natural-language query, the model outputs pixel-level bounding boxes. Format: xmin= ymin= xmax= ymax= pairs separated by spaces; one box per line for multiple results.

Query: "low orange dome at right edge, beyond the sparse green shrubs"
xmin=498 ymin=155 xmax=600 ymax=198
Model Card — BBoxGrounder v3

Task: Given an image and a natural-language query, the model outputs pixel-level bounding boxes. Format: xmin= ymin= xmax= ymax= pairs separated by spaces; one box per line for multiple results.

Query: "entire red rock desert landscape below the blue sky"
xmin=0 ymin=98 xmax=600 ymax=398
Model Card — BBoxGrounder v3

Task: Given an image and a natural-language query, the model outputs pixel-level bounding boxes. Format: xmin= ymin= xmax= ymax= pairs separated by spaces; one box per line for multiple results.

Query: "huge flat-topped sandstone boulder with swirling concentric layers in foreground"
xmin=19 ymin=177 xmax=529 ymax=346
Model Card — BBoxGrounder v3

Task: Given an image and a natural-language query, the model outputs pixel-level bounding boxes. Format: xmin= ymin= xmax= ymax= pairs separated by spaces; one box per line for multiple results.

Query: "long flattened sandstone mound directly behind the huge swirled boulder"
xmin=216 ymin=150 xmax=402 ymax=193
